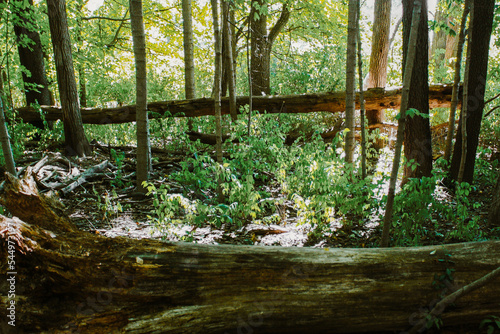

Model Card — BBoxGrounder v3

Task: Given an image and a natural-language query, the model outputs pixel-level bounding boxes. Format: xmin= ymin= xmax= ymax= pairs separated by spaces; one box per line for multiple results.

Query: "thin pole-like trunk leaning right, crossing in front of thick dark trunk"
xmin=380 ymin=1 xmax=425 ymax=247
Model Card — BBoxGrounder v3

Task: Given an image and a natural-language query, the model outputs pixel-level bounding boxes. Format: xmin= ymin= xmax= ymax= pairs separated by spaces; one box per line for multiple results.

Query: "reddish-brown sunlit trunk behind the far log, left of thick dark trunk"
xmin=365 ymin=0 xmax=392 ymax=137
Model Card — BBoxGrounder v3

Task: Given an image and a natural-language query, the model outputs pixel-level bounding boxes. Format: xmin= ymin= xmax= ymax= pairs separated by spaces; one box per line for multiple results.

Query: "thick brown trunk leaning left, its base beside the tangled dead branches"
xmin=47 ymin=0 xmax=91 ymax=156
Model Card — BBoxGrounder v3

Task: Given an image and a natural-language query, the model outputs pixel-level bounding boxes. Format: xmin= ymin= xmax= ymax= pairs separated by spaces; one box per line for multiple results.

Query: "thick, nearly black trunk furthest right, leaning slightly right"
xmin=450 ymin=0 xmax=495 ymax=183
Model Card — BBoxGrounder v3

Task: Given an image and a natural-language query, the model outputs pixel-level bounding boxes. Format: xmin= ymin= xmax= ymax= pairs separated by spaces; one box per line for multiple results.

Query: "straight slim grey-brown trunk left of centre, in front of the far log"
xmin=130 ymin=0 xmax=151 ymax=193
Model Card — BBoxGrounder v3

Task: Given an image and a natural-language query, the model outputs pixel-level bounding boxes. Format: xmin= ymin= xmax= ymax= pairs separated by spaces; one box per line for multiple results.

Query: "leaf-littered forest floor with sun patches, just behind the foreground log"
xmin=13 ymin=137 xmax=500 ymax=248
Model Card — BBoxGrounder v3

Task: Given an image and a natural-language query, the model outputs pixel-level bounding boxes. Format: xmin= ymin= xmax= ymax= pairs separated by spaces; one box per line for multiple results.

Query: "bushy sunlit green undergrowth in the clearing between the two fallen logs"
xmin=148 ymin=114 xmax=383 ymax=240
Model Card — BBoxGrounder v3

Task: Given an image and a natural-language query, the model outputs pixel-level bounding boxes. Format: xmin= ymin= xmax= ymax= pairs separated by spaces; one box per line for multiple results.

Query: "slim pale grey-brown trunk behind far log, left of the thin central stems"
xmin=182 ymin=0 xmax=196 ymax=100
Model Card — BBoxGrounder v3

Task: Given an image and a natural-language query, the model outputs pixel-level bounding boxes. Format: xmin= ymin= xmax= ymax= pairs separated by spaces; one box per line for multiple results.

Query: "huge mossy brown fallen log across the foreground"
xmin=0 ymin=172 xmax=500 ymax=333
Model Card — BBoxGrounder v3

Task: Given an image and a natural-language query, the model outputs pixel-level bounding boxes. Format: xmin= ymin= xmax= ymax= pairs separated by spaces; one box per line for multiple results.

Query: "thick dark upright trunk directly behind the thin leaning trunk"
xmin=403 ymin=0 xmax=432 ymax=180
